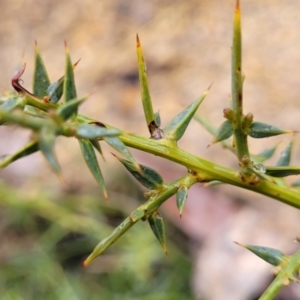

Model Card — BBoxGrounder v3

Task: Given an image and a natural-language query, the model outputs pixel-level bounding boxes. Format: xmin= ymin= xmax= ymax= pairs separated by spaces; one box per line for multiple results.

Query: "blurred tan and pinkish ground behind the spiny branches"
xmin=0 ymin=0 xmax=300 ymax=300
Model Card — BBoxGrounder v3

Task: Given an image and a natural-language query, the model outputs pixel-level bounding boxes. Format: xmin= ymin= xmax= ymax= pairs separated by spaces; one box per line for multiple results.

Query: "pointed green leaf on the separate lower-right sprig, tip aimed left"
xmin=236 ymin=242 xmax=287 ymax=266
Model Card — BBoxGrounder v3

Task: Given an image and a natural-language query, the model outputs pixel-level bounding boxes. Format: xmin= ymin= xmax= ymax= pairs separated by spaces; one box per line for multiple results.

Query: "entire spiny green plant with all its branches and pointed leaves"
xmin=0 ymin=1 xmax=300 ymax=299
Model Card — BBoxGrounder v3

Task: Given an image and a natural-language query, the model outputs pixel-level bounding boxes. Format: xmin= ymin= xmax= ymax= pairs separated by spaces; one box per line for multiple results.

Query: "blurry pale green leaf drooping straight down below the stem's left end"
xmin=39 ymin=127 xmax=61 ymax=177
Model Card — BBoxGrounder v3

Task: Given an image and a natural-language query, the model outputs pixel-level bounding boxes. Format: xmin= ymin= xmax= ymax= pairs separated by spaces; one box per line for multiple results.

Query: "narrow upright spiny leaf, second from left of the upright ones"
xmin=63 ymin=44 xmax=77 ymax=102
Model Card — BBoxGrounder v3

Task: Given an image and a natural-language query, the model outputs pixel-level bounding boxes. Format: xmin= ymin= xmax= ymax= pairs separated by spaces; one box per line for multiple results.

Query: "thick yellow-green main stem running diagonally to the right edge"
xmin=0 ymin=106 xmax=300 ymax=208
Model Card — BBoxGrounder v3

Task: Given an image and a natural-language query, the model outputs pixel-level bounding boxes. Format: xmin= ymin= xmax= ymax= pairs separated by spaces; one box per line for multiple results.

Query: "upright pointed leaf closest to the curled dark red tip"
xmin=33 ymin=42 xmax=50 ymax=98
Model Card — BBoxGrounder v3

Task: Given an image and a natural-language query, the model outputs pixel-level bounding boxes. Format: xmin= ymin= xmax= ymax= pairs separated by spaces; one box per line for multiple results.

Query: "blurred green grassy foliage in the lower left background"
xmin=0 ymin=181 xmax=192 ymax=300
